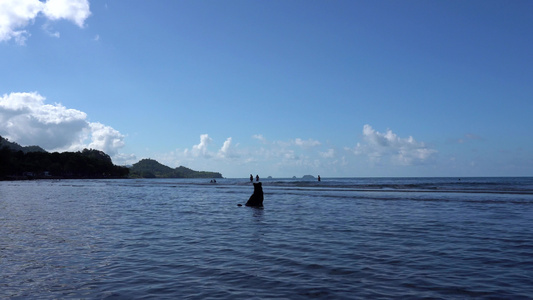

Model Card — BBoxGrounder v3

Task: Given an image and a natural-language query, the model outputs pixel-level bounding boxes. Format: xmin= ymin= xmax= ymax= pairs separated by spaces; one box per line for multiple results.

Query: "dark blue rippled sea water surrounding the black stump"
xmin=0 ymin=178 xmax=533 ymax=299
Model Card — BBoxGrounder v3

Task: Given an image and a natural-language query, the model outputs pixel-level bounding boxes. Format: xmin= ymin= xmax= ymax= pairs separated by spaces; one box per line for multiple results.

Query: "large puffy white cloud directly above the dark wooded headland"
xmin=0 ymin=92 xmax=124 ymax=157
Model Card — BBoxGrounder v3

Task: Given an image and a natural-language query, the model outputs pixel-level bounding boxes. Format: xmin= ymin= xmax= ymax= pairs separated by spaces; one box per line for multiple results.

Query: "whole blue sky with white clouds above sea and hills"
xmin=0 ymin=0 xmax=533 ymax=178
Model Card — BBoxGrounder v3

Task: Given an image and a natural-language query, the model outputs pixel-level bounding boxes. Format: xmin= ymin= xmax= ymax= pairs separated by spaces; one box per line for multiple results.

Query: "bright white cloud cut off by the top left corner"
xmin=0 ymin=0 xmax=91 ymax=45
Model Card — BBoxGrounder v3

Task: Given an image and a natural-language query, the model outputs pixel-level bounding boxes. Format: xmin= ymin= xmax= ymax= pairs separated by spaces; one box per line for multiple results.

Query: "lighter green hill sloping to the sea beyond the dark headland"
xmin=130 ymin=159 xmax=222 ymax=178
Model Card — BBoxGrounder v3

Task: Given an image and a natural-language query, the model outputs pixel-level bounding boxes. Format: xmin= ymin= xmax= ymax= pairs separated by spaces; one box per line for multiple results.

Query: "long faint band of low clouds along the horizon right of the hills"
xmin=154 ymin=125 xmax=437 ymax=177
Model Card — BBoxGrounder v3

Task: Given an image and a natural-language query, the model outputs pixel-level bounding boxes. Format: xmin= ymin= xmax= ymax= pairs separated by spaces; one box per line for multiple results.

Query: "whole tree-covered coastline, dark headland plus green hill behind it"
xmin=0 ymin=136 xmax=223 ymax=180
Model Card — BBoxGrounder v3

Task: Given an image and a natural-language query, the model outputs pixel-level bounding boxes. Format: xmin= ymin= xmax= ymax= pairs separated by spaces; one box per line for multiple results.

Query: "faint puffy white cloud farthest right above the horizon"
xmin=351 ymin=125 xmax=437 ymax=165
